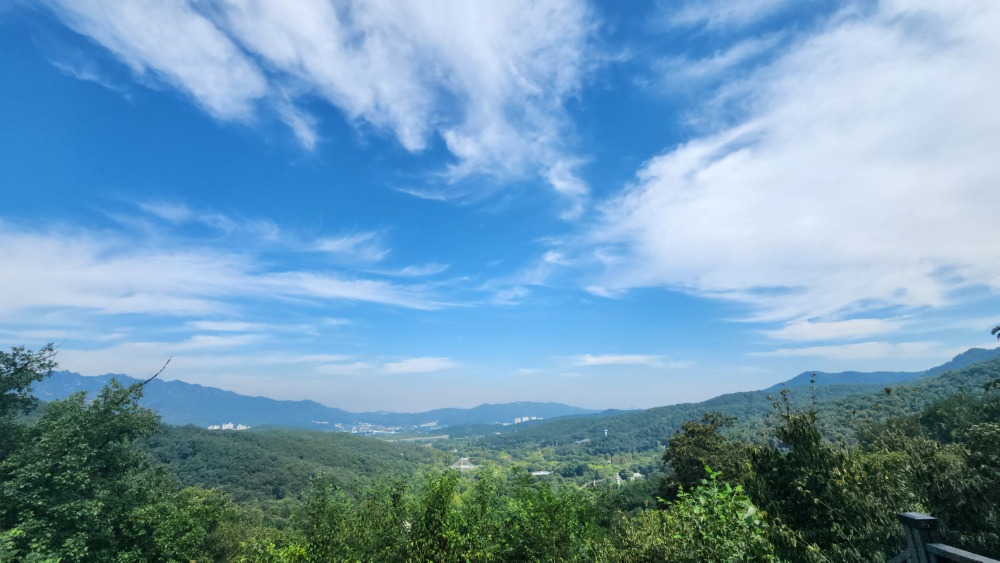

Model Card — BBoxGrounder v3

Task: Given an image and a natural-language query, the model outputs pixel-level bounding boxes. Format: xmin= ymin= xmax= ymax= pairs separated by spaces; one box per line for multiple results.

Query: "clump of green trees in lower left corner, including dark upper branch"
xmin=0 ymin=347 xmax=235 ymax=562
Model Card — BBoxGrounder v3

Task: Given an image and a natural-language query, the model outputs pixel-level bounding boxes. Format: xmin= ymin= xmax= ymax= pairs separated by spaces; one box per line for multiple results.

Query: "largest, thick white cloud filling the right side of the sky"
xmin=591 ymin=1 xmax=1000 ymax=322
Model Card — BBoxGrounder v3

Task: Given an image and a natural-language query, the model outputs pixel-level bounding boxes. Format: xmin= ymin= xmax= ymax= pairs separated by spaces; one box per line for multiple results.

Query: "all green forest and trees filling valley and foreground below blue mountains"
xmin=0 ymin=346 xmax=1000 ymax=562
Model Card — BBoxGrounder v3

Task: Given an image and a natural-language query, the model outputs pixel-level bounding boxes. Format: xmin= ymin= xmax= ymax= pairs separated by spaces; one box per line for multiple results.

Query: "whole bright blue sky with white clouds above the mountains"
xmin=0 ymin=0 xmax=1000 ymax=411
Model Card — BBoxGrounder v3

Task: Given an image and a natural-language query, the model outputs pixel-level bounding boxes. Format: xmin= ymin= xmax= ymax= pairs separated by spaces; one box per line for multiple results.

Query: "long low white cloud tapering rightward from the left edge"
xmin=0 ymin=220 xmax=442 ymax=317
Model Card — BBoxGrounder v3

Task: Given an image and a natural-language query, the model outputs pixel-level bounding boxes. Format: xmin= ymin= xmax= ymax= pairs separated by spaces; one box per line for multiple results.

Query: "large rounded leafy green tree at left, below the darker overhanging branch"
xmin=0 ymin=382 xmax=158 ymax=560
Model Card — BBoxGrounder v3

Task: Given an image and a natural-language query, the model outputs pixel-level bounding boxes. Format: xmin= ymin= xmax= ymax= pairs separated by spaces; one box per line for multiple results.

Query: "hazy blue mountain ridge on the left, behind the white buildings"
xmin=34 ymin=371 xmax=598 ymax=430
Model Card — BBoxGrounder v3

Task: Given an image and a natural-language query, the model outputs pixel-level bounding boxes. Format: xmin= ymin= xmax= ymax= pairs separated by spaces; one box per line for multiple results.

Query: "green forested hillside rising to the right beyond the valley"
xmin=480 ymin=350 xmax=1000 ymax=455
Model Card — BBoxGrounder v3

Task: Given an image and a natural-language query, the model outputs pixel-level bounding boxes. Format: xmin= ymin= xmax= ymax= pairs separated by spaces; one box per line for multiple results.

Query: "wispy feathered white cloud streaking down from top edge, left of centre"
xmin=41 ymin=0 xmax=596 ymax=206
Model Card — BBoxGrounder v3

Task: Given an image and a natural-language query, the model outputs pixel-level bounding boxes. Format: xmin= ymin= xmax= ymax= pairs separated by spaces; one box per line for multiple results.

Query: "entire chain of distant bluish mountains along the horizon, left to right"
xmin=34 ymin=348 xmax=1000 ymax=436
